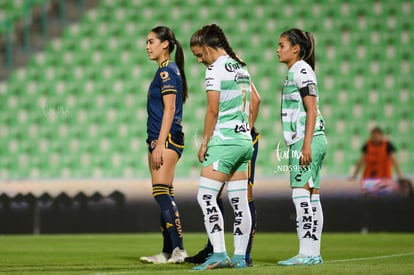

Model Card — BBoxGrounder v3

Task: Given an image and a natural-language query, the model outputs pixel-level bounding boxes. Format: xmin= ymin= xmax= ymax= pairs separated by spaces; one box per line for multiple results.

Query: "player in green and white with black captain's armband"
xmin=277 ymin=29 xmax=327 ymax=265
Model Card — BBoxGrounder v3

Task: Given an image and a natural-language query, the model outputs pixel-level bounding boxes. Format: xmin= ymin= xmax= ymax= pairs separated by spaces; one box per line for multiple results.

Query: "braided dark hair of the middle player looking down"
xmin=190 ymin=24 xmax=246 ymax=66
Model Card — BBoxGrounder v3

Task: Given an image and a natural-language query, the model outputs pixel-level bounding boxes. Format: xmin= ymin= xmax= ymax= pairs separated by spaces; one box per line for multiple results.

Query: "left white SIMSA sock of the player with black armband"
xmin=292 ymin=188 xmax=313 ymax=256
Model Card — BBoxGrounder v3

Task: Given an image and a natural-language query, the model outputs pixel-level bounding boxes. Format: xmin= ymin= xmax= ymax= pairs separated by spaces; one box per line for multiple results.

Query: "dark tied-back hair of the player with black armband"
xmin=280 ymin=29 xmax=315 ymax=70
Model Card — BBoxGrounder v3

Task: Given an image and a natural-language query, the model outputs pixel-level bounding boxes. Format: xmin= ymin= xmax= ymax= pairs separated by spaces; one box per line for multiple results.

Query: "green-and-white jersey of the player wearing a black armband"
xmin=282 ymin=60 xmax=325 ymax=145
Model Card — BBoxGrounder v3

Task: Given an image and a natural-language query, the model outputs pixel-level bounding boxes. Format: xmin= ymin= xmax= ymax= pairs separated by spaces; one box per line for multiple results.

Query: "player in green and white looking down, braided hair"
xmin=190 ymin=24 xmax=253 ymax=270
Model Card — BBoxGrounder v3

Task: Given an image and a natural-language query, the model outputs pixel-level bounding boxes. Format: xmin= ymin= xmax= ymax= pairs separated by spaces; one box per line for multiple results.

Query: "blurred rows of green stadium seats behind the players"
xmin=0 ymin=0 xmax=414 ymax=179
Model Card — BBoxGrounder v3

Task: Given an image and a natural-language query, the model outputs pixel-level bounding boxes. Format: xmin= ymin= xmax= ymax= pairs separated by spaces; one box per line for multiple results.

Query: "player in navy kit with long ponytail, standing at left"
xmin=140 ymin=26 xmax=188 ymax=264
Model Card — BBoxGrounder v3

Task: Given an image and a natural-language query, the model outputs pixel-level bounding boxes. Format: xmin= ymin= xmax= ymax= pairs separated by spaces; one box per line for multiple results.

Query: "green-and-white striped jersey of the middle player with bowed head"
xmin=205 ymin=56 xmax=251 ymax=143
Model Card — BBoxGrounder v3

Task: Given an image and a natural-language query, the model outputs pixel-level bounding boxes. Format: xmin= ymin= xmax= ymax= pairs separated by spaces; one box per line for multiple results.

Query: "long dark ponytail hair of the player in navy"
xmin=151 ymin=26 xmax=188 ymax=102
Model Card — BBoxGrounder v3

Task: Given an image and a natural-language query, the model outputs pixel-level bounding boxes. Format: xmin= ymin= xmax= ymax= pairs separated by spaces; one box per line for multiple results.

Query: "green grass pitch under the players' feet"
xmin=0 ymin=233 xmax=414 ymax=275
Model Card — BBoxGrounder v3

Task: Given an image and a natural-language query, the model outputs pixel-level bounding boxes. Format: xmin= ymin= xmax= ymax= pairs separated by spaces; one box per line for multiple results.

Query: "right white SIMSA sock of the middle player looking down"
xmin=227 ymin=179 xmax=252 ymax=257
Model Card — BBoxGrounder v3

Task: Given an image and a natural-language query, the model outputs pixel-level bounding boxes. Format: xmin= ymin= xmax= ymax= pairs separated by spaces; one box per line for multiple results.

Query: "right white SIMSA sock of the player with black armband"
xmin=311 ymin=194 xmax=323 ymax=256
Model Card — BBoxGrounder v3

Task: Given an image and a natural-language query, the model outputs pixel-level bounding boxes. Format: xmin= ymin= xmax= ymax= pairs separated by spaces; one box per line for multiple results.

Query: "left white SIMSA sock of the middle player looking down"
xmin=197 ymin=177 xmax=226 ymax=253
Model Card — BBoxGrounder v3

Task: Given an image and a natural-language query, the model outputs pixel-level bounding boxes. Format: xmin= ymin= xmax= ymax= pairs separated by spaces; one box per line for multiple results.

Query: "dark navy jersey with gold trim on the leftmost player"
xmin=147 ymin=60 xmax=183 ymax=140
